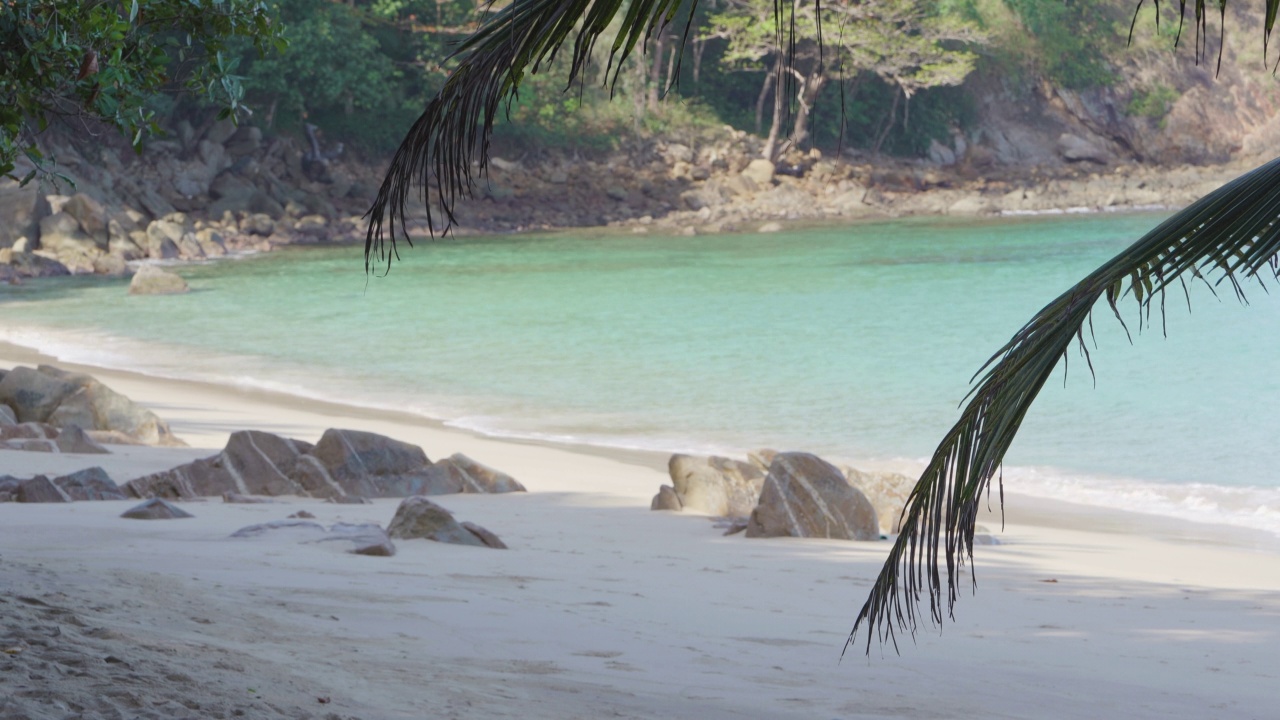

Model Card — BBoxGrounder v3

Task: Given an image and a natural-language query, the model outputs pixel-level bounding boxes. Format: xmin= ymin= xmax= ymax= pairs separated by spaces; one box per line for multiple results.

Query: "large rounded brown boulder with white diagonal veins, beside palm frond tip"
xmin=746 ymin=452 xmax=879 ymax=541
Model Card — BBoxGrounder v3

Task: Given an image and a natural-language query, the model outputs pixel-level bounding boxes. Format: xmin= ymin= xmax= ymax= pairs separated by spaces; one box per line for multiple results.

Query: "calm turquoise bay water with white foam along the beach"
xmin=0 ymin=215 xmax=1280 ymax=532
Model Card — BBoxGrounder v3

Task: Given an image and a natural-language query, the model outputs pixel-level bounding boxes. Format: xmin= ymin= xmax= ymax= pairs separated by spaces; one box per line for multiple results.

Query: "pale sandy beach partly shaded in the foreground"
xmin=0 ymin=347 xmax=1280 ymax=720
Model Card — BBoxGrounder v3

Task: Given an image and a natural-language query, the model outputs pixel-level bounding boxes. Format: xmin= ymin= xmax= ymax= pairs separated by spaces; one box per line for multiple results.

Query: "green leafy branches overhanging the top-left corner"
xmin=0 ymin=0 xmax=283 ymax=182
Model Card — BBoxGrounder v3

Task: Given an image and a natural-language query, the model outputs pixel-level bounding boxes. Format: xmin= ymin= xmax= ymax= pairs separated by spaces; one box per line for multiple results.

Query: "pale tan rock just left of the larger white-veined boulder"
xmin=667 ymin=454 xmax=764 ymax=518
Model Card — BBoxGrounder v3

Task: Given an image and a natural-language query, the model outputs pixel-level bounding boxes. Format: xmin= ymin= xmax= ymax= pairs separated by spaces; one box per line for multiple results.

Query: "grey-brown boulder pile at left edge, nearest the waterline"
xmin=0 ymin=365 xmax=184 ymax=446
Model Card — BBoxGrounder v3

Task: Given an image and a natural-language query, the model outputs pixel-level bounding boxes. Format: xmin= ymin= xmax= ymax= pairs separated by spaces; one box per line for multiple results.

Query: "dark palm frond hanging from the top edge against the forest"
xmin=365 ymin=0 xmax=696 ymax=272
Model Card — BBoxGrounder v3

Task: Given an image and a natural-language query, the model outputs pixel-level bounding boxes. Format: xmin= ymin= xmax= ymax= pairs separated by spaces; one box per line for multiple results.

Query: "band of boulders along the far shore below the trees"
xmin=0 ymin=116 xmax=1247 ymax=282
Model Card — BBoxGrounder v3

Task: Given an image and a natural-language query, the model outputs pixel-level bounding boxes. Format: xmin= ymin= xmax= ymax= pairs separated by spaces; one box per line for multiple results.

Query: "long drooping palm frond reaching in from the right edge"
xmin=845 ymin=159 xmax=1280 ymax=652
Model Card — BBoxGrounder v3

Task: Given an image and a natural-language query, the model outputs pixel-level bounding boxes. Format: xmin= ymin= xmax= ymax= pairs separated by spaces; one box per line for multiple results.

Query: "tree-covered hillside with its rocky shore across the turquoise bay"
xmin=0 ymin=0 xmax=1280 ymax=280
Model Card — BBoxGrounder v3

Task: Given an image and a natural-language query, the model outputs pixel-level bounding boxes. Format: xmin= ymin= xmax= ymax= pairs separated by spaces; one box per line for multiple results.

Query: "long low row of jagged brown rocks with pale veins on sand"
xmin=125 ymin=429 xmax=524 ymax=502
